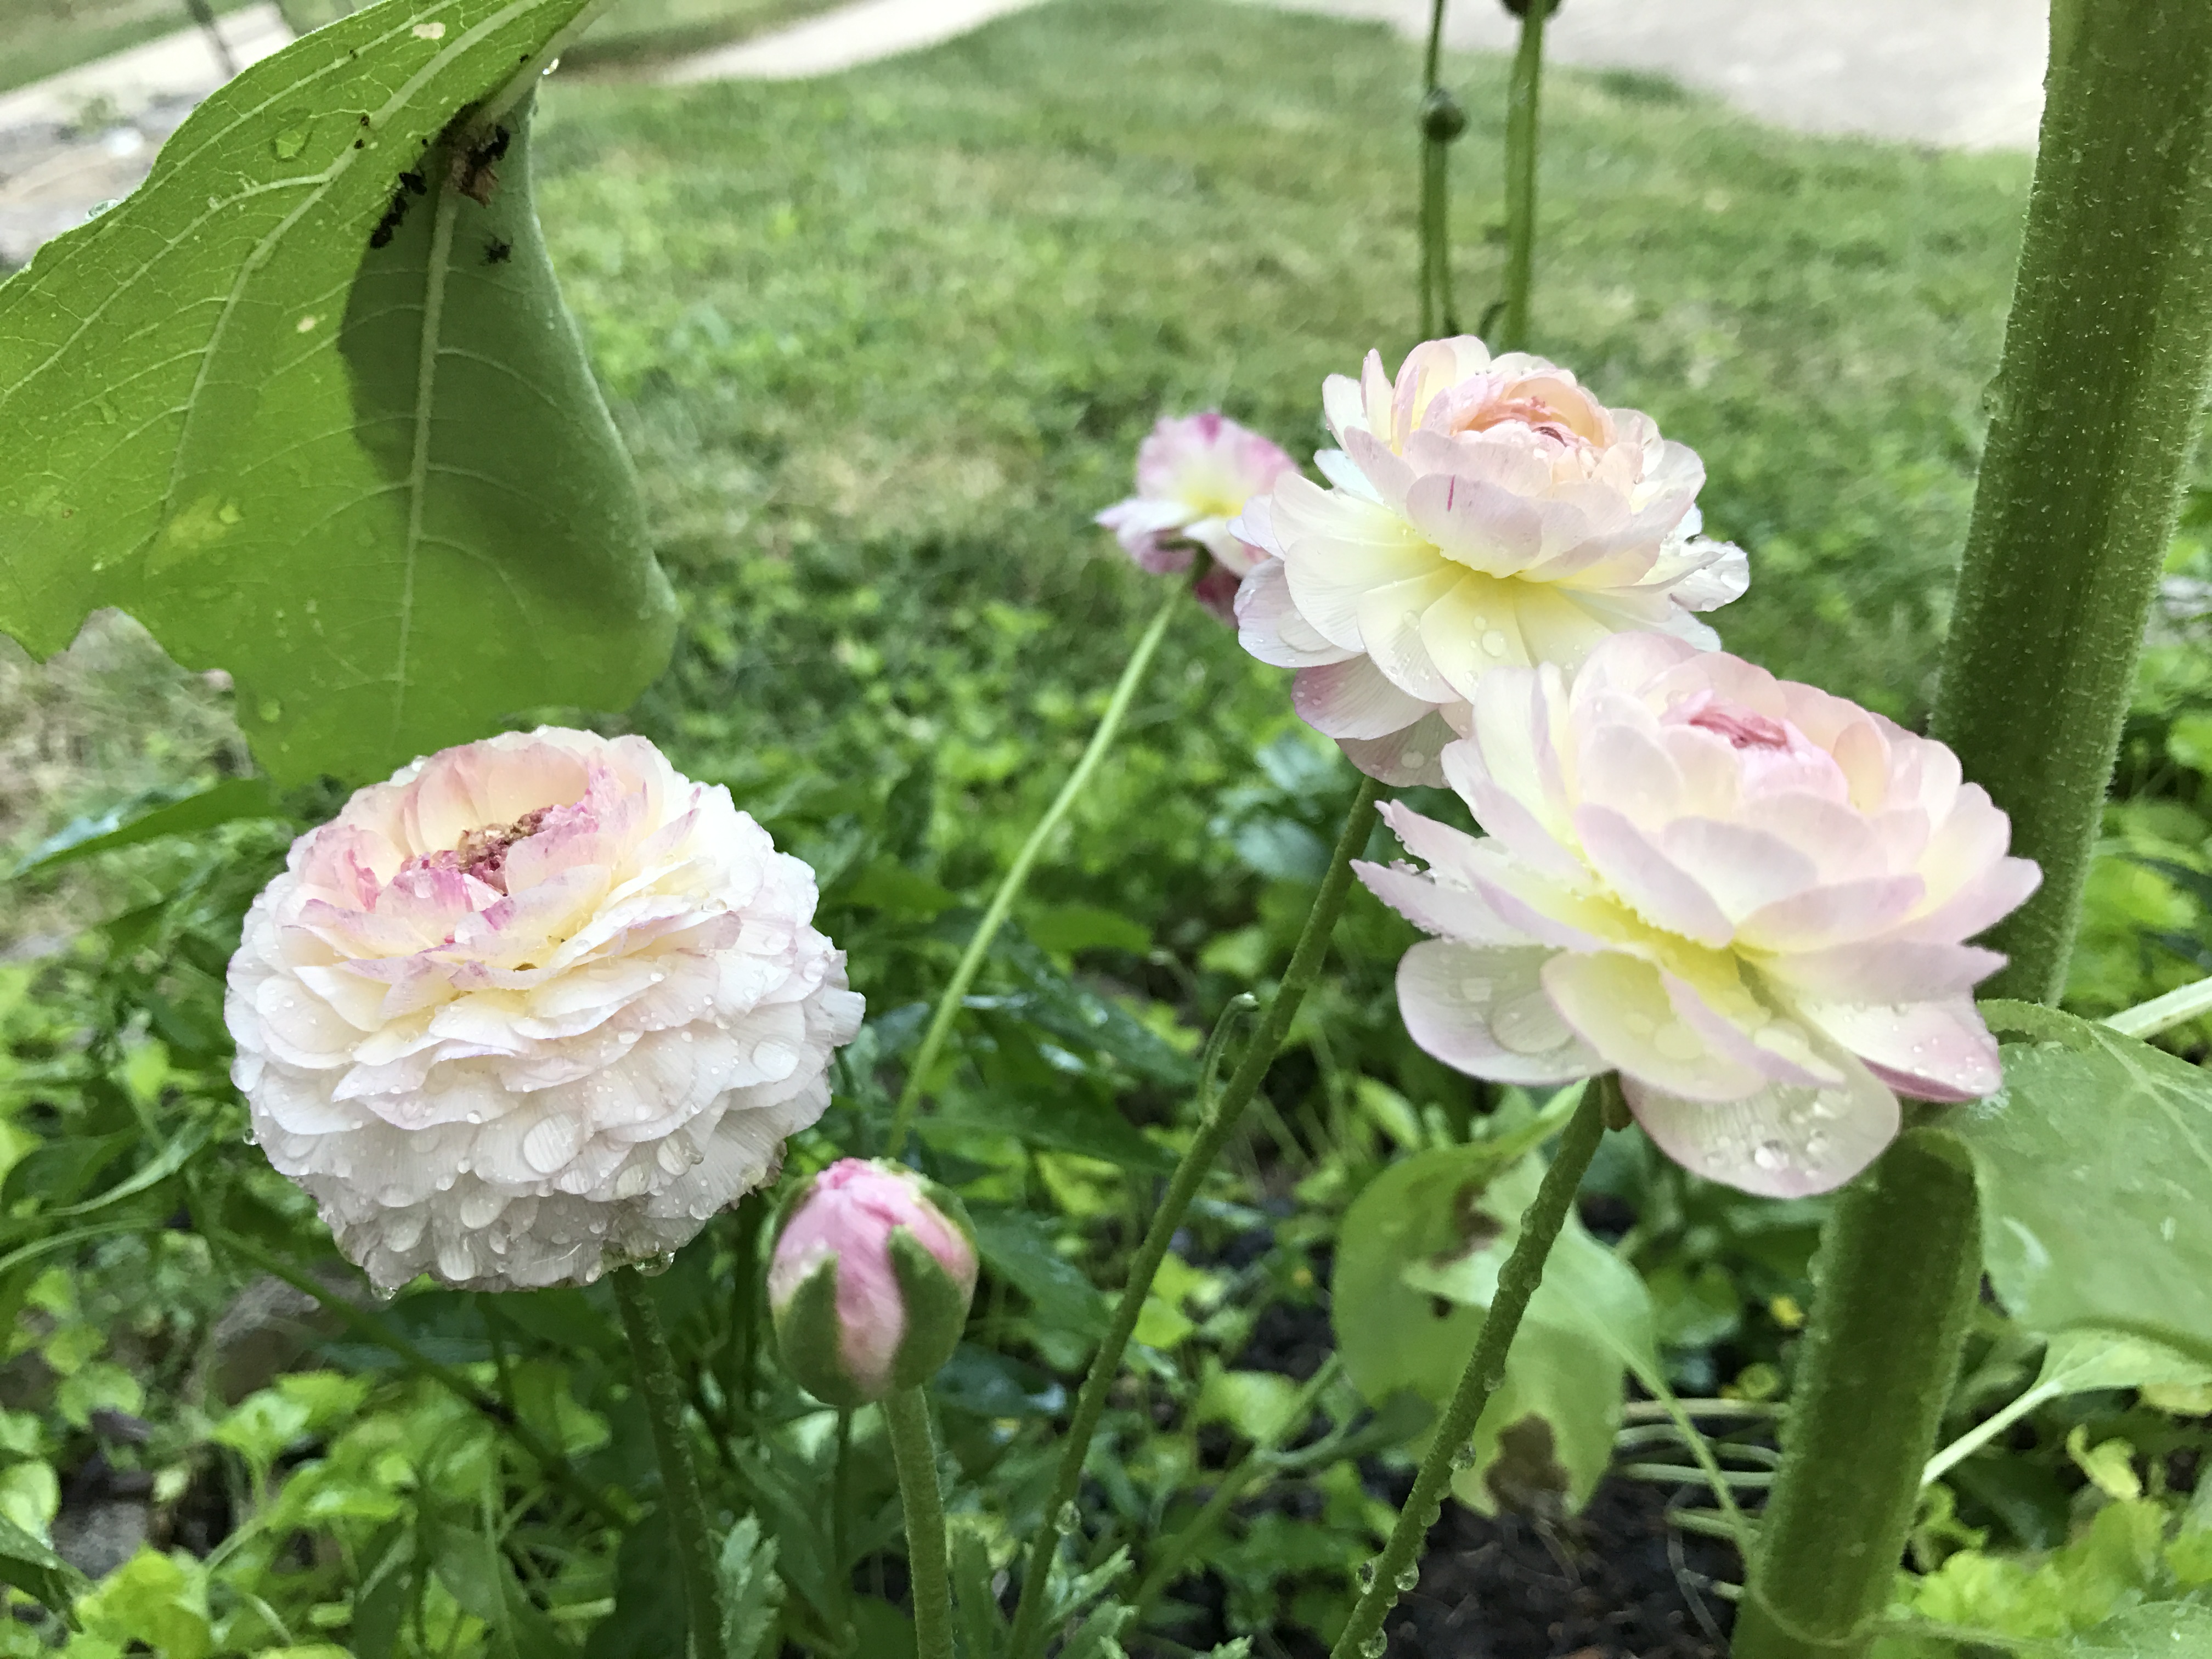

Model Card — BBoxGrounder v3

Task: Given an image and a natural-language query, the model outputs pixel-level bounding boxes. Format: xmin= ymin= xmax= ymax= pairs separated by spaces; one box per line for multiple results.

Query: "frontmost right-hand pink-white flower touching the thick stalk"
xmin=1356 ymin=635 xmax=2037 ymax=1197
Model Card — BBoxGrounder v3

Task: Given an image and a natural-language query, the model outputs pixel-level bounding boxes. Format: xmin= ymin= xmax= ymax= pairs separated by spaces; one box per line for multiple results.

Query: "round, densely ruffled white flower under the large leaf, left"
xmin=223 ymin=728 xmax=860 ymax=1290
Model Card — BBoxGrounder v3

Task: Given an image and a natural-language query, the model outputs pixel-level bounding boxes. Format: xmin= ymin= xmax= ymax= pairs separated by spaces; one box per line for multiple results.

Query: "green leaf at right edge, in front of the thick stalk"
xmin=1946 ymin=1002 xmax=2212 ymax=1361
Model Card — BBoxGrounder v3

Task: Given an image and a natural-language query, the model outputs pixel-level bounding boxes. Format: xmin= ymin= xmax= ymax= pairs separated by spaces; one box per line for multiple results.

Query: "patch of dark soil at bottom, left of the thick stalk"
xmin=1385 ymin=1480 xmax=1743 ymax=1659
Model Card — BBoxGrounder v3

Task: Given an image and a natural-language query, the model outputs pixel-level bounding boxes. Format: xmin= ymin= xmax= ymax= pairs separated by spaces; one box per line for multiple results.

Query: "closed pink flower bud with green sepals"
xmin=768 ymin=1157 xmax=975 ymax=1407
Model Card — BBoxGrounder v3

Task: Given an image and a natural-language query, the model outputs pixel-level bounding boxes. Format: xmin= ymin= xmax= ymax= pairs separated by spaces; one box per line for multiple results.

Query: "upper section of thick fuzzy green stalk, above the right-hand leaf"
xmin=1936 ymin=0 xmax=2212 ymax=1002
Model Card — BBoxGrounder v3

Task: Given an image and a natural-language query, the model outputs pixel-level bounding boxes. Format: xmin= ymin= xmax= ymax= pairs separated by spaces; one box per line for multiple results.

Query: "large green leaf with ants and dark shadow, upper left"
xmin=0 ymin=0 xmax=673 ymax=783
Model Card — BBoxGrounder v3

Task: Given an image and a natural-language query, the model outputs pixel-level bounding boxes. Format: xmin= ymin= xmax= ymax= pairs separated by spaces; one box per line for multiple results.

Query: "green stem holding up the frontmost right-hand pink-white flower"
xmin=1329 ymin=1086 xmax=1608 ymax=1659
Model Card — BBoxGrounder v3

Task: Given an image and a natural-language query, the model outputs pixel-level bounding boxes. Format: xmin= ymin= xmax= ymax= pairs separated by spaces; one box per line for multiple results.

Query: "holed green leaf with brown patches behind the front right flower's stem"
xmin=1329 ymin=1142 xmax=1655 ymax=1511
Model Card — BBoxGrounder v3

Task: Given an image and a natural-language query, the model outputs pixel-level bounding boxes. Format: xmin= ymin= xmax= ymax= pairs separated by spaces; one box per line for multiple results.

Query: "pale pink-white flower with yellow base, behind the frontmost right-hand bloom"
xmin=1230 ymin=336 xmax=1750 ymax=783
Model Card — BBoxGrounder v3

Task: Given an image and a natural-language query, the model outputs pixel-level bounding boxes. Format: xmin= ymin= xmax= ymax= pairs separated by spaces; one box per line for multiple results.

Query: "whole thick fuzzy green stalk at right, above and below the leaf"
xmin=1734 ymin=0 xmax=2212 ymax=1659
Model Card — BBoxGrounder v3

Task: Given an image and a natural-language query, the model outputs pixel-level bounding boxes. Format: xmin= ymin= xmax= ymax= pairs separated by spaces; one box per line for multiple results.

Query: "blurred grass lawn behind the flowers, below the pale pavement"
xmin=517 ymin=0 xmax=2028 ymax=911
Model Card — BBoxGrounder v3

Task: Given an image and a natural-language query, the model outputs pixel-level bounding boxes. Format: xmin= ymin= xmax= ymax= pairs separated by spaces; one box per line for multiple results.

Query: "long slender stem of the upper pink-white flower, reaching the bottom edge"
xmin=1007 ymin=776 xmax=1383 ymax=1659
